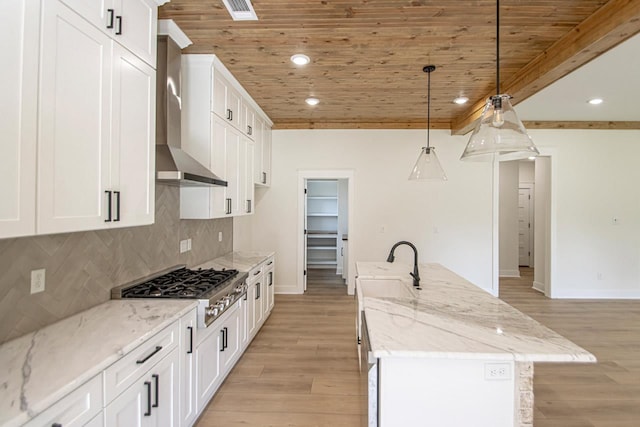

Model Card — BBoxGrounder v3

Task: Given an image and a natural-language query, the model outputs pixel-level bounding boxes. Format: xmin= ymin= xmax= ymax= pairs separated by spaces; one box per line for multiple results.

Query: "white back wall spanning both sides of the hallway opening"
xmin=242 ymin=130 xmax=640 ymax=298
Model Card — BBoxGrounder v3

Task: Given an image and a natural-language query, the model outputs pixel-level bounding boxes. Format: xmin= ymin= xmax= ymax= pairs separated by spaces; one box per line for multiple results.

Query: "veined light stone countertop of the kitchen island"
xmin=356 ymin=262 xmax=596 ymax=362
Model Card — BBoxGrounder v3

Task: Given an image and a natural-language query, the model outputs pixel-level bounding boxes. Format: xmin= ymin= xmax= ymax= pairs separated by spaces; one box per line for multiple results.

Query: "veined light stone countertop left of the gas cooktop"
xmin=0 ymin=299 xmax=197 ymax=426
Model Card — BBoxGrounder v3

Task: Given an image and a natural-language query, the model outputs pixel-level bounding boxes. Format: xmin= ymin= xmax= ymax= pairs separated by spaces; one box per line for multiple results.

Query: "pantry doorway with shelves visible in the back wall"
xmin=297 ymin=170 xmax=354 ymax=294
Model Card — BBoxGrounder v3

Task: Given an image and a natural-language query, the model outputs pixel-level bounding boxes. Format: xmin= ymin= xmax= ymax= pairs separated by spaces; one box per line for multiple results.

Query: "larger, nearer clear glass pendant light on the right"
xmin=460 ymin=0 xmax=540 ymax=161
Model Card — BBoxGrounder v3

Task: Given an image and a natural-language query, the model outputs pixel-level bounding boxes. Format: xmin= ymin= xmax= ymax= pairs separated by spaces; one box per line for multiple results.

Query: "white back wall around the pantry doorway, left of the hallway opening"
xmin=245 ymin=130 xmax=493 ymax=293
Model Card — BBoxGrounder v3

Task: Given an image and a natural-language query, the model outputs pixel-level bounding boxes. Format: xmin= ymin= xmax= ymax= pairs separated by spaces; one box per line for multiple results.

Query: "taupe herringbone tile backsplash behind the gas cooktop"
xmin=0 ymin=185 xmax=233 ymax=343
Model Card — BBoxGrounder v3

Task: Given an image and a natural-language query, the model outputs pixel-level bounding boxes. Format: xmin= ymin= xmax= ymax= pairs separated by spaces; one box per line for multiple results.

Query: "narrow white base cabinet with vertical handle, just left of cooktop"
xmin=179 ymin=310 xmax=198 ymax=426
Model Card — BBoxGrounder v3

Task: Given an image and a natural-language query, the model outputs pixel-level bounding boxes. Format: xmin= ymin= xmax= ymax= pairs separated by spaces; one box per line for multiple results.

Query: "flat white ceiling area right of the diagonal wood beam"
xmin=514 ymin=34 xmax=640 ymax=121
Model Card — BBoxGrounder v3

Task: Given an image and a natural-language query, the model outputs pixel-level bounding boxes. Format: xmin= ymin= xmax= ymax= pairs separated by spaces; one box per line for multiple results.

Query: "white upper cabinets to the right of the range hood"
xmin=180 ymin=55 xmax=270 ymax=219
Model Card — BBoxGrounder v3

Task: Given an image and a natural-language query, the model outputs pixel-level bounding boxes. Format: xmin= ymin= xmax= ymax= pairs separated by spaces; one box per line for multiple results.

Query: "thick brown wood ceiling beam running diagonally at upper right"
xmin=451 ymin=0 xmax=640 ymax=135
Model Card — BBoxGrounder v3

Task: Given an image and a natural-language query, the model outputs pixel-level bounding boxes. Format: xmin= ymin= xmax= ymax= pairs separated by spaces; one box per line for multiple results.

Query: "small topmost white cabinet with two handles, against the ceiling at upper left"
xmin=61 ymin=0 xmax=158 ymax=69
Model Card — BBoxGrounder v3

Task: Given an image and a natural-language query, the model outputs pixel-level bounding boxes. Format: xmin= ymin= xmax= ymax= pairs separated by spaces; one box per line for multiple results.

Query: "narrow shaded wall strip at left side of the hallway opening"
xmin=498 ymin=161 xmax=520 ymax=277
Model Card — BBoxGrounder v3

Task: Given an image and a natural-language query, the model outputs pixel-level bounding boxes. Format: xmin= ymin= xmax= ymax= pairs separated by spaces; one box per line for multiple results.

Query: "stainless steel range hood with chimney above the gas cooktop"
xmin=156 ymin=35 xmax=227 ymax=187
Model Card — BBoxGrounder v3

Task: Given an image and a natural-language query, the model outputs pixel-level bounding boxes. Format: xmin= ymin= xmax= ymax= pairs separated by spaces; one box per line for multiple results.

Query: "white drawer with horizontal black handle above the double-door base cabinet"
xmin=104 ymin=322 xmax=180 ymax=404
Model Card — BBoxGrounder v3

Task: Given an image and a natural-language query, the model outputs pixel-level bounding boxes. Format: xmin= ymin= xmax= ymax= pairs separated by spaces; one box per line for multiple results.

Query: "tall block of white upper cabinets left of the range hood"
xmin=0 ymin=0 xmax=157 ymax=238
